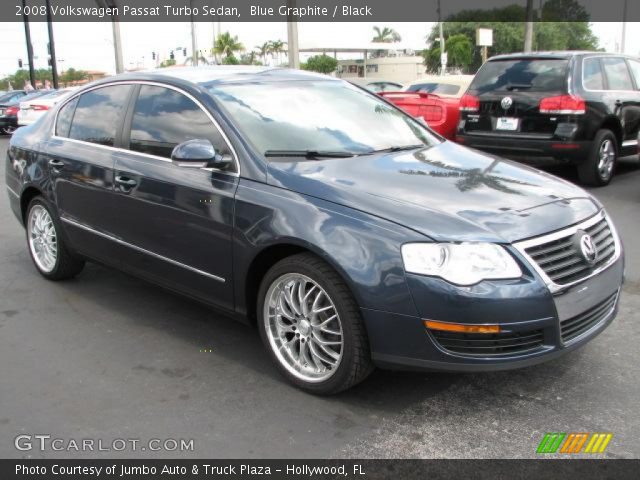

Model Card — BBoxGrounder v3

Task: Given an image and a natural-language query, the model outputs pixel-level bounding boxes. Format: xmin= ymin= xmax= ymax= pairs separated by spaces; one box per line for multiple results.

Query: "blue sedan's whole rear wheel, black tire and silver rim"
xmin=26 ymin=197 xmax=84 ymax=280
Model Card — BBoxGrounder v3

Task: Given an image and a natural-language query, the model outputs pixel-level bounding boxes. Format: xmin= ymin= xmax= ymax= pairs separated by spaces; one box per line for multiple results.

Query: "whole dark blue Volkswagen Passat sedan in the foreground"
xmin=6 ymin=67 xmax=623 ymax=393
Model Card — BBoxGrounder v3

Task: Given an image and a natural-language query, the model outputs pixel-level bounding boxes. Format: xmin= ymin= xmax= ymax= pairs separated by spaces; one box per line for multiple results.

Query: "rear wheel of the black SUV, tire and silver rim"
xmin=578 ymin=130 xmax=618 ymax=187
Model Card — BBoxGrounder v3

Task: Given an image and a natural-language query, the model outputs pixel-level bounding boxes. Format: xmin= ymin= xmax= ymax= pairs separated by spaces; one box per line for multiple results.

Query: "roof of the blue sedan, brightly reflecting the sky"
xmin=100 ymin=65 xmax=336 ymax=85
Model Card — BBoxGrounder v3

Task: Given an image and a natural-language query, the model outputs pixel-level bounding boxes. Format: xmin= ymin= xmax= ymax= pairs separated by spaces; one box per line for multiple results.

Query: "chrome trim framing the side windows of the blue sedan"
xmin=51 ymin=80 xmax=240 ymax=177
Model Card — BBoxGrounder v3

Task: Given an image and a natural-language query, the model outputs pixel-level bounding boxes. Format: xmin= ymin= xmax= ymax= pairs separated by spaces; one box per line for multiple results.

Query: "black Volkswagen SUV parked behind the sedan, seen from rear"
xmin=456 ymin=52 xmax=640 ymax=185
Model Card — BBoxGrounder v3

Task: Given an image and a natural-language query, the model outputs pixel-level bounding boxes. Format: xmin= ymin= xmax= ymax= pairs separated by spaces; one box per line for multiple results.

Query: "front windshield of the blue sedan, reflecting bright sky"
xmin=210 ymin=80 xmax=439 ymax=157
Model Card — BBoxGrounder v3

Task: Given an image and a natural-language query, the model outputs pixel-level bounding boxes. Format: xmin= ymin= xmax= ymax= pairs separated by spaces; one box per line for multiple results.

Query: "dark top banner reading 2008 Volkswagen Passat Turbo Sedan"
xmin=0 ymin=0 xmax=640 ymax=22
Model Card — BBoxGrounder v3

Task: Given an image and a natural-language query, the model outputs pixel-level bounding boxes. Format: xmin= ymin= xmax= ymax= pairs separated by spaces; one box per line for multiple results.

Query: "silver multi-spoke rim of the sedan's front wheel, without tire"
xmin=263 ymin=273 xmax=344 ymax=383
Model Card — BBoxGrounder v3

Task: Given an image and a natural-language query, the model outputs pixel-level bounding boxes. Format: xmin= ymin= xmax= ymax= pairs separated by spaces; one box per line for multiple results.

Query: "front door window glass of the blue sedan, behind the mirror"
xmin=129 ymin=85 xmax=230 ymax=162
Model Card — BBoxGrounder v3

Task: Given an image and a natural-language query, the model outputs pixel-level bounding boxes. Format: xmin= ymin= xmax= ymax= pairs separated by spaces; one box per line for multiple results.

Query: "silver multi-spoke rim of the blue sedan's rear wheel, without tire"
xmin=27 ymin=205 xmax=58 ymax=273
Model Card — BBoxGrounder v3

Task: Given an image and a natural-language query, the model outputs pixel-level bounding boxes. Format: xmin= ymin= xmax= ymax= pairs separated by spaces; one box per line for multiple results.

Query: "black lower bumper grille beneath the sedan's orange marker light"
xmin=430 ymin=330 xmax=544 ymax=357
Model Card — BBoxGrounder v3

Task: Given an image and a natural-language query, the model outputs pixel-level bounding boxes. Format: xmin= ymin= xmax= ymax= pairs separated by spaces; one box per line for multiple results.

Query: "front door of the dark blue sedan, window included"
xmin=114 ymin=84 xmax=238 ymax=310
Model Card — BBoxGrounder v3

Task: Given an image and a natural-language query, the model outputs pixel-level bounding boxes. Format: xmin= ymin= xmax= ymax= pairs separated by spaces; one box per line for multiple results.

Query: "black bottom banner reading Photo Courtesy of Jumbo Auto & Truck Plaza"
xmin=0 ymin=459 xmax=640 ymax=480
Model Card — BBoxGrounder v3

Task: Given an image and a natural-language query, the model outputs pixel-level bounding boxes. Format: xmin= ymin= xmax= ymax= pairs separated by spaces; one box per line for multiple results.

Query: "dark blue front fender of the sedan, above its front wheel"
xmin=234 ymin=179 xmax=426 ymax=315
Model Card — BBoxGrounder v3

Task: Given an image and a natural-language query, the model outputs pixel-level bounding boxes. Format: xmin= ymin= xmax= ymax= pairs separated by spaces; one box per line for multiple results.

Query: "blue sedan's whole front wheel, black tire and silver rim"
xmin=257 ymin=253 xmax=373 ymax=395
